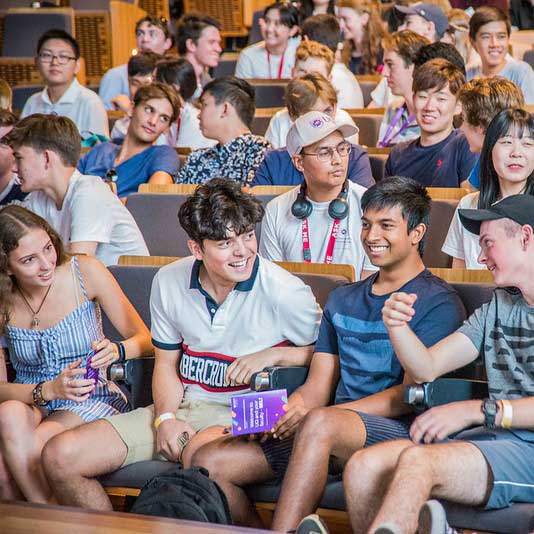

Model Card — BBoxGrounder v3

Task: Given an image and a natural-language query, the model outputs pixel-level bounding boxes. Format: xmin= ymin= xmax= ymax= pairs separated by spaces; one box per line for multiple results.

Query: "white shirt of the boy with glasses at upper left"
xmin=21 ymin=78 xmax=109 ymax=138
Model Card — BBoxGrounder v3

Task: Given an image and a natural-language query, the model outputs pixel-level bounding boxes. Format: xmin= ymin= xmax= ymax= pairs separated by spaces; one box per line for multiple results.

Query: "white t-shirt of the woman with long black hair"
xmin=441 ymin=191 xmax=486 ymax=269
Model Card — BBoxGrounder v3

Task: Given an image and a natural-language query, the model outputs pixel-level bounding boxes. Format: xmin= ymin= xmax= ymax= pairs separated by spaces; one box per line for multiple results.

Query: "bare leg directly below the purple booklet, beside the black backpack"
xmin=192 ymin=436 xmax=274 ymax=528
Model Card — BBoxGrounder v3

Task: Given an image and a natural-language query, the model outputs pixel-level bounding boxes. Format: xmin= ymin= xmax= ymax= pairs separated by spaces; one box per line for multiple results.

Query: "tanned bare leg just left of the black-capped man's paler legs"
xmin=272 ymin=407 xmax=366 ymax=532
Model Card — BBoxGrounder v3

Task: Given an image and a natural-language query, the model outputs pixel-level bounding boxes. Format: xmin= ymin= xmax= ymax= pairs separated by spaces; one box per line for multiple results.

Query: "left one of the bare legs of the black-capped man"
xmin=343 ymin=439 xmax=413 ymax=532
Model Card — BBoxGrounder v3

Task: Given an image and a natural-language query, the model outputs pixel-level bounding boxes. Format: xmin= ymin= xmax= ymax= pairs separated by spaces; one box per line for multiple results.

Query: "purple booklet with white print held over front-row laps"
xmin=232 ymin=389 xmax=288 ymax=436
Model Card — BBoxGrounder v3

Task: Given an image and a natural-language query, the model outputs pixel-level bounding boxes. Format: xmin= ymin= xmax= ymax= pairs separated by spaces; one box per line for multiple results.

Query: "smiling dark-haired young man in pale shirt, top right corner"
xmin=467 ymin=6 xmax=534 ymax=104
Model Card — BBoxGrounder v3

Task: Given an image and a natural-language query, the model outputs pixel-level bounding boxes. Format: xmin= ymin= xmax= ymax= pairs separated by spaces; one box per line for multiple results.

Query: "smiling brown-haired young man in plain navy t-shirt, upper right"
xmin=385 ymin=59 xmax=476 ymax=187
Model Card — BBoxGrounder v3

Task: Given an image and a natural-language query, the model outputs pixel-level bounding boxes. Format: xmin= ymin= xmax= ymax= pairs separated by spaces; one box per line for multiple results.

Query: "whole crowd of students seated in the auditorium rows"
xmin=0 ymin=0 xmax=534 ymax=534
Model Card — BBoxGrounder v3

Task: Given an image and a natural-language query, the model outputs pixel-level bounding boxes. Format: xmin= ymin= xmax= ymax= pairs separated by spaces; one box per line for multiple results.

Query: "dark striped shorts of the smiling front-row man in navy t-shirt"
xmin=260 ymin=412 xmax=414 ymax=484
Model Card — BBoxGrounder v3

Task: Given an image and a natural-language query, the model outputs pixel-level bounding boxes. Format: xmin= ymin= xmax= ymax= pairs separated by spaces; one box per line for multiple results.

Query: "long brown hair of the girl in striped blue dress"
xmin=0 ymin=205 xmax=68 ymax=334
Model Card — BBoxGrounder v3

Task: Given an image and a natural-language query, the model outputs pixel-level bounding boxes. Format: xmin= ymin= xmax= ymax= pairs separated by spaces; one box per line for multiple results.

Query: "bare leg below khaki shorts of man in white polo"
xmin=43 ymin=419 xmax=128 ymax=510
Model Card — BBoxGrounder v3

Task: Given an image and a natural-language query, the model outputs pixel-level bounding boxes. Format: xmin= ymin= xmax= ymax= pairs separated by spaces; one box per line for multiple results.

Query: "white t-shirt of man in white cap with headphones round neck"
xmin=260 ymin=181 xmax=376 ymax=280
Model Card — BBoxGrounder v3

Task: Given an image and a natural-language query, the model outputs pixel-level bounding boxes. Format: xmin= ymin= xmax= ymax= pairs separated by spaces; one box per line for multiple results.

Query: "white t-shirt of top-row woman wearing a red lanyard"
xmin=235 ymin=37 xmax=300 ymax=79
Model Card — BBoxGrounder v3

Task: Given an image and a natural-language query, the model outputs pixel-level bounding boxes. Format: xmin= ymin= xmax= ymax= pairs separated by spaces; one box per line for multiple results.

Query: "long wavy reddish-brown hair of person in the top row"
xmin=342 ymin=0 xmax=386 ymax=74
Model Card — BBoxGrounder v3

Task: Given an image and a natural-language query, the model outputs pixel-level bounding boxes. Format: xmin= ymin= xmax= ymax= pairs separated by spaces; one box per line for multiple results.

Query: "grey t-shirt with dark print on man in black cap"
xmin=458 ymin=288 xmax=534 ymax=399
